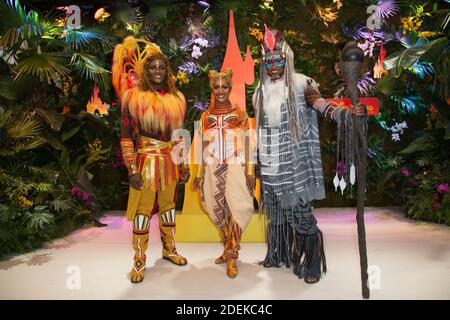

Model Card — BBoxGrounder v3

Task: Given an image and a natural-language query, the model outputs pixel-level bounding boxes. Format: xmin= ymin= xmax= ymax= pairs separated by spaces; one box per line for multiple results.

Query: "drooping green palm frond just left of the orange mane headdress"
xmin=70 ymin=53 xmax=111 ymax=88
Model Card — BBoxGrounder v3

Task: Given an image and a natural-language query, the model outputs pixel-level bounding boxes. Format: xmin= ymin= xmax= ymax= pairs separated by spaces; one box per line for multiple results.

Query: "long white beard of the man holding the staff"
xmin=263 ymin=79 xmax=286 ymax=127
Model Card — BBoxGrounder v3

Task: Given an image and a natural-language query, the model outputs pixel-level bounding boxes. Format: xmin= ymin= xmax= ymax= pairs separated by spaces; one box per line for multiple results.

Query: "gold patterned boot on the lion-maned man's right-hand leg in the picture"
xmin=159 ymin=209 xmax=187 ymax=266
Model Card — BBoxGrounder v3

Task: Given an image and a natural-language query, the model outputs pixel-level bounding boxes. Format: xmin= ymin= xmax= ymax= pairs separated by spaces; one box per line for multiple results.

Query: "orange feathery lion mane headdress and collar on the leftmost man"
xmin=112 ymin=36 xmax=186 ymax=132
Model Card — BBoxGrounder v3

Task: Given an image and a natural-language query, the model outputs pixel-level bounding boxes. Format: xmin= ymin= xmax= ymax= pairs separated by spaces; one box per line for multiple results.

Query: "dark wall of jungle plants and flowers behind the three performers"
xmin=0 ymin=0 xmax=450 ymax=256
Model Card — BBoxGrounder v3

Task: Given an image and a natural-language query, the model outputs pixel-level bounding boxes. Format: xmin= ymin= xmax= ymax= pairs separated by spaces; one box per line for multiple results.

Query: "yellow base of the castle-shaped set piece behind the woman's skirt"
xmin=175 ymin=165 xmax=266 ymax=242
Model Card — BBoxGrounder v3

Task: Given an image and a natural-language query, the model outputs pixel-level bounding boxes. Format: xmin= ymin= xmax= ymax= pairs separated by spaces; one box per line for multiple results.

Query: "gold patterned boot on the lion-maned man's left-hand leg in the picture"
xmin=130 ymin=214 xmax=150 ymax=283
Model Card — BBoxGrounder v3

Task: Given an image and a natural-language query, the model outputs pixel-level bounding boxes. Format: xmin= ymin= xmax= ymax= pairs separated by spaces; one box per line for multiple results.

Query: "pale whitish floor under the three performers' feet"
xmin=0 ymin=208 xmax=450 ymax=300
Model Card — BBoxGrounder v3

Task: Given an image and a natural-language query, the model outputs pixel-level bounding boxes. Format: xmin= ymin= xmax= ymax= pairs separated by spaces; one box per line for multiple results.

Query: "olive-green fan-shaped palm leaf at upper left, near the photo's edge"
xmin=14 ymin=52 xmax=70 ymax=83
